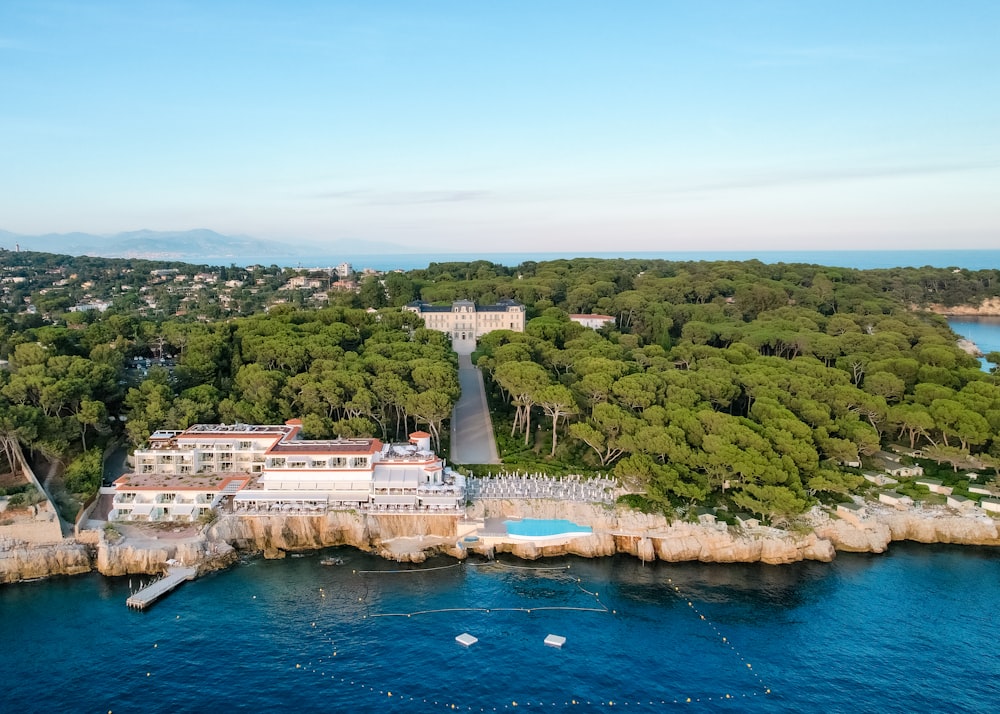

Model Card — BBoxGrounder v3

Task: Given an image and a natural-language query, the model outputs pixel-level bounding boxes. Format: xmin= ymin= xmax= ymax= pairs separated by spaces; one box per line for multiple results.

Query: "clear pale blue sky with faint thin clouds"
xmin=0 ymin=0 xmax=1000 ymax=252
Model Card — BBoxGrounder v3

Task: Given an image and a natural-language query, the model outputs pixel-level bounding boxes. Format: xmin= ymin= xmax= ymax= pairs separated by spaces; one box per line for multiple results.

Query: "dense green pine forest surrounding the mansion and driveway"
xmin=0 ymin=254 xmax=1000 ymax=522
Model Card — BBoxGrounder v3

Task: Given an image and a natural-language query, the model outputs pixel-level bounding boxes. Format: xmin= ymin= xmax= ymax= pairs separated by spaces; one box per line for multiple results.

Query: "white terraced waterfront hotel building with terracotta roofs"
xmin=109 ymin=419 xmax=465 ymax=521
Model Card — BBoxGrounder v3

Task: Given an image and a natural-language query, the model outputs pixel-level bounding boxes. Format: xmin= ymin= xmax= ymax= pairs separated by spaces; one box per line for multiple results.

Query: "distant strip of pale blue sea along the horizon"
xmin=229 ymin=250 xmax=1000 ymax=270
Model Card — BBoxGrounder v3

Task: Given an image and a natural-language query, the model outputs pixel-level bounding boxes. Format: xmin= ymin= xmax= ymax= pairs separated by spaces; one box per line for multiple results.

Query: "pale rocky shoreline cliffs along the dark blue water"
xmin=0 ymin=499 xmax=1000 ymax=583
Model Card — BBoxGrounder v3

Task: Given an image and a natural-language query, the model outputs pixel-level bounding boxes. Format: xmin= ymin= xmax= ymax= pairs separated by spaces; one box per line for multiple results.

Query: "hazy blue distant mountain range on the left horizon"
xmin=0 ymin=228 xmax=412 ymax=263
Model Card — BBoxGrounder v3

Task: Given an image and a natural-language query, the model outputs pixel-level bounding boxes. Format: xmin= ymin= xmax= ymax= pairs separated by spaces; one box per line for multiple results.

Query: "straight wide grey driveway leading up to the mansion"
xmin=451 ymin=354 xmax=500 ymax=464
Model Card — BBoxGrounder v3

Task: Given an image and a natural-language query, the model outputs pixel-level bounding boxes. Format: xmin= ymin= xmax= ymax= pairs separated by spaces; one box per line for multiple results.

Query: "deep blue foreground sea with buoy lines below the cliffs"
xmin=0 ymin=544 xmax=1000 ymax=714
